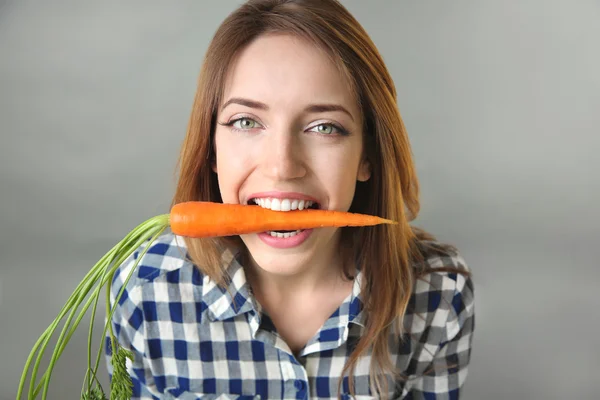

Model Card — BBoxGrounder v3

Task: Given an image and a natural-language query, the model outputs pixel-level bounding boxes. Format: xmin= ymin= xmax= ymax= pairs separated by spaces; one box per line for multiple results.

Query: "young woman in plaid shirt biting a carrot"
xmin=107 ymin=0 xmax=474 ymax=399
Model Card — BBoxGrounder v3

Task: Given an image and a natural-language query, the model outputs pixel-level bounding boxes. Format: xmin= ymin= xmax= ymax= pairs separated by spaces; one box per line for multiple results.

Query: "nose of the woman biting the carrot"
xmin=262 ymin=132 xmax=306 ymax=180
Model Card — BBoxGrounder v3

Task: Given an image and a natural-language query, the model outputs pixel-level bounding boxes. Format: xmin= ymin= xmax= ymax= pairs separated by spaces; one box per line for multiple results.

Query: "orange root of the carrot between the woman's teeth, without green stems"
xmin=170 ymin=201 xmax=397 ymax=238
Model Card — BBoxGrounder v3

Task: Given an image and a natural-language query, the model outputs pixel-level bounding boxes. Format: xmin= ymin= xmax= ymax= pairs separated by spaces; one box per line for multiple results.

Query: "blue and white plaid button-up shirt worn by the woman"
xmin=106 ymin=234 xmax=474 ymax=400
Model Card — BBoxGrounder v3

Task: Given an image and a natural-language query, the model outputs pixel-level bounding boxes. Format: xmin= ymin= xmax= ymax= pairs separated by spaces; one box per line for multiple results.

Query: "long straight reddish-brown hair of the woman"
xmin=173 ymin=0 xmax=464 ymax=396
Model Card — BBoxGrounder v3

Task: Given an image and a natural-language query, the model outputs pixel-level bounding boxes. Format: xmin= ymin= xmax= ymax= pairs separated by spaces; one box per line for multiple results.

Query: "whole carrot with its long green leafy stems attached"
xmin=17 ymin=202 xmax=396 ymax=400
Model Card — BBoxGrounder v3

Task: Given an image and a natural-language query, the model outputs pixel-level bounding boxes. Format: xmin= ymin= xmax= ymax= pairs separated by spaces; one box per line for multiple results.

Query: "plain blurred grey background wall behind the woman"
xmin=0 ymin=0 xmax=600 ymax=400
